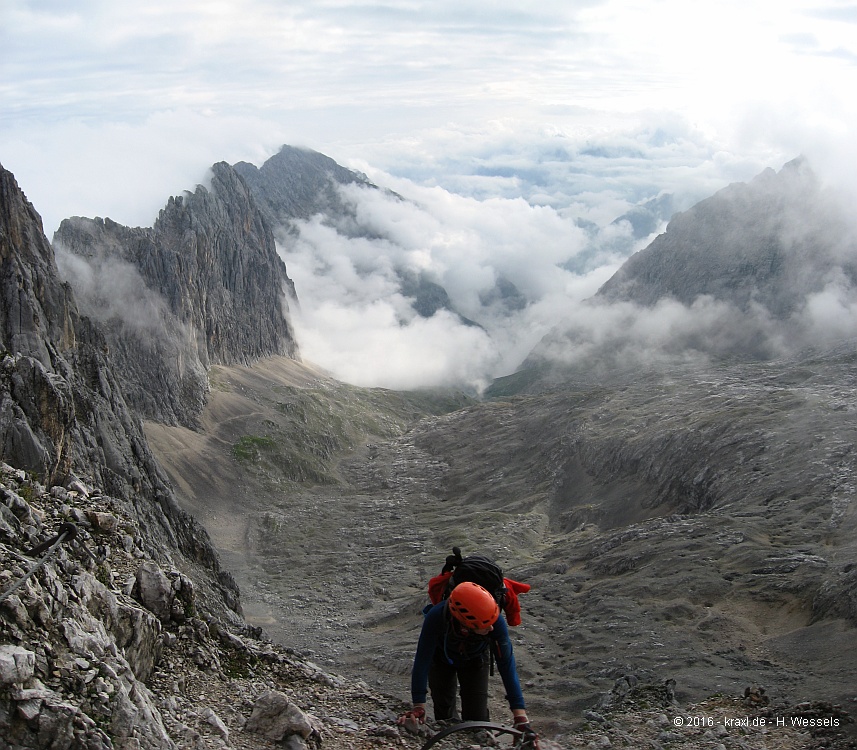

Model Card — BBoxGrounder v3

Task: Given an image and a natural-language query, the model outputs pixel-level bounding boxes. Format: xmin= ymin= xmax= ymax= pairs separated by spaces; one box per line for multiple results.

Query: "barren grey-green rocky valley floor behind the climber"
xmin=146 ymin=348 xmax=857 ymax=734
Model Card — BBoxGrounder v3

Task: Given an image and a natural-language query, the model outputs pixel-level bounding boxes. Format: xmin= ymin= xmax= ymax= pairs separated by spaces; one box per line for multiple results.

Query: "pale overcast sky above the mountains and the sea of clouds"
xmin=0 ymin=0 xmax=857 ymax=233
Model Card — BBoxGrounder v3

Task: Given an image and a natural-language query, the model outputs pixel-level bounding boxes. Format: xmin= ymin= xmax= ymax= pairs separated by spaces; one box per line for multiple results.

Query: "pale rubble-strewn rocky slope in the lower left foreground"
xmin=0 ymin=461 xmax=462 ymax=750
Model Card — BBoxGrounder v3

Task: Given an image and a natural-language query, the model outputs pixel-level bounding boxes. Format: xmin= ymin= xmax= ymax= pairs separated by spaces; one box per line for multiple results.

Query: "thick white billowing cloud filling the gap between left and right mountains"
xmin=281 ymin=173 xmax=606 ymax=390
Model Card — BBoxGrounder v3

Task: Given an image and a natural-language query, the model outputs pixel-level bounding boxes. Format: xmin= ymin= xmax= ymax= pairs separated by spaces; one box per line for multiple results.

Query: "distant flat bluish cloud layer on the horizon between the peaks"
xmin=334 ymin=112 xmax=776 ymax=225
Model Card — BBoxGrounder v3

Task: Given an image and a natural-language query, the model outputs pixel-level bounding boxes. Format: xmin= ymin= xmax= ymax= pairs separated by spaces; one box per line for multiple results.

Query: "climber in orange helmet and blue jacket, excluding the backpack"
xmin=399 ymin=581 xmax=538 ymax=748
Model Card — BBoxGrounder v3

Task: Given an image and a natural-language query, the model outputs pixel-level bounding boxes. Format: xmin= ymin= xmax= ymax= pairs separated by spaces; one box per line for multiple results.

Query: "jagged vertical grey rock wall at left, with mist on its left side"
xmin=54 ymin=163 xmax=298 ymax=426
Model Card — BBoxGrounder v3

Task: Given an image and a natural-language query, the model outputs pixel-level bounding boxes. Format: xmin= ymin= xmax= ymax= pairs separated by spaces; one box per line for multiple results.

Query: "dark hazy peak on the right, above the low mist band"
xmin=598 ymin=157 xmax=857 ymax=319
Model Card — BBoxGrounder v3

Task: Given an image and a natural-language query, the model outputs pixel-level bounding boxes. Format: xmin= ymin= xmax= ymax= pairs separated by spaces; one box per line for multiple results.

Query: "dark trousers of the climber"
xmin=429 ymin=653 xmax=490 ymax=721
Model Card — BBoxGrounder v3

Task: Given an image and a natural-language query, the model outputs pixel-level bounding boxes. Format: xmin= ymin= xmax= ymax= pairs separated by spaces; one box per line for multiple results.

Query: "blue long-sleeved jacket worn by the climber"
xmin=411 ymin=601 xmax=526 ymax=709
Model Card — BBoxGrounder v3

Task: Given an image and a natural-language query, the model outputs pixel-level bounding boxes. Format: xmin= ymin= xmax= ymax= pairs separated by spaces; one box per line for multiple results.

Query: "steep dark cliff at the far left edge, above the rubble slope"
xmin=0 ymin=167 xmax=238 ymax=624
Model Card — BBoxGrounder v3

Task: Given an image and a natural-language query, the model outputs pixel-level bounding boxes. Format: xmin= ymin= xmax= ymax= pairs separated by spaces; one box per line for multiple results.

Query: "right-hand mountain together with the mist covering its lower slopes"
xmin=489 ymin=157 xmax=857 ymax=395
